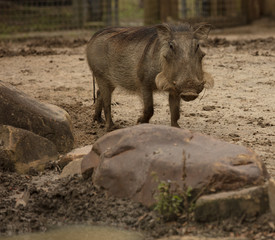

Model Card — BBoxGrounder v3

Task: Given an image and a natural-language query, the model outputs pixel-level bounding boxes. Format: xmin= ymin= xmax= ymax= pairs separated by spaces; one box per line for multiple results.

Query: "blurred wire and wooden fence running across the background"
xmin=0 ymin=0 xmax=275 ymax=34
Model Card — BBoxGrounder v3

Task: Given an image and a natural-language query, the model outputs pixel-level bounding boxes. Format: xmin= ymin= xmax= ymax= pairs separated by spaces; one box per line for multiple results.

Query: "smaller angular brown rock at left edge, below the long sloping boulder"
xmin=0 ymin=125 xmax=58 ymax=173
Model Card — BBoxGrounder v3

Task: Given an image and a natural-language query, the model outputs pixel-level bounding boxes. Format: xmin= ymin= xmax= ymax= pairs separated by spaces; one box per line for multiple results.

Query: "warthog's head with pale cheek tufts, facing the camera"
xmin=155 ymin=24 xmax=213 ymax=101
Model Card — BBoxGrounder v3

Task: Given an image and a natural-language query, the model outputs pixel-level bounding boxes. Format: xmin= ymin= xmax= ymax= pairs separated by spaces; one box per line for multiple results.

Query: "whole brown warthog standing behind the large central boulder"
xmin=87 ymin=24 xmax=213 ymax=130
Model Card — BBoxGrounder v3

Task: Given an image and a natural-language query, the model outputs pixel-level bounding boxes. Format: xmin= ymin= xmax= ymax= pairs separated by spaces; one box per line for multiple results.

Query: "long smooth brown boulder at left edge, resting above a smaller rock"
xmin=0 ymin=81 xmax=74 ymax=152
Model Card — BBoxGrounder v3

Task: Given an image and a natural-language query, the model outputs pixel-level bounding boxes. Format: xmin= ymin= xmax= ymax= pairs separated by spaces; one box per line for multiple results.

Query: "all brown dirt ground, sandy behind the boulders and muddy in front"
xmin=0 ymin=19 xmax=275 ymax=239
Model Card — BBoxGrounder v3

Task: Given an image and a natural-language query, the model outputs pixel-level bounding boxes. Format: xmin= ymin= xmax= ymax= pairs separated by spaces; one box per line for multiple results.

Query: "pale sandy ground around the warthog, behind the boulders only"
xmin=0 ymin=20 xmax=275 ymax=239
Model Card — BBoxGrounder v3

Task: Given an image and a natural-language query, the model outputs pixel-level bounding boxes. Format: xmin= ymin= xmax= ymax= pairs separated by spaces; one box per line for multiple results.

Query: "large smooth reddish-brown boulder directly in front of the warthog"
xmin=82 ymin=124 xmax=267 ymax=205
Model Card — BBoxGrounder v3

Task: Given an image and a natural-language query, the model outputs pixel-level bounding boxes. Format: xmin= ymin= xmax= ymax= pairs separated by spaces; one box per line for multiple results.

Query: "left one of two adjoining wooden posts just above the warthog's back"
xmin=144 ymin=0 xmax=160 ymax=25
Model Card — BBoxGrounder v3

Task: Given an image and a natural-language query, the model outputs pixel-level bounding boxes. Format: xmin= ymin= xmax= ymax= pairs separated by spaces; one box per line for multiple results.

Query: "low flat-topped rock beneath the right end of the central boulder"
xmin=195 ymin=185 xmax=269 ymax=222
